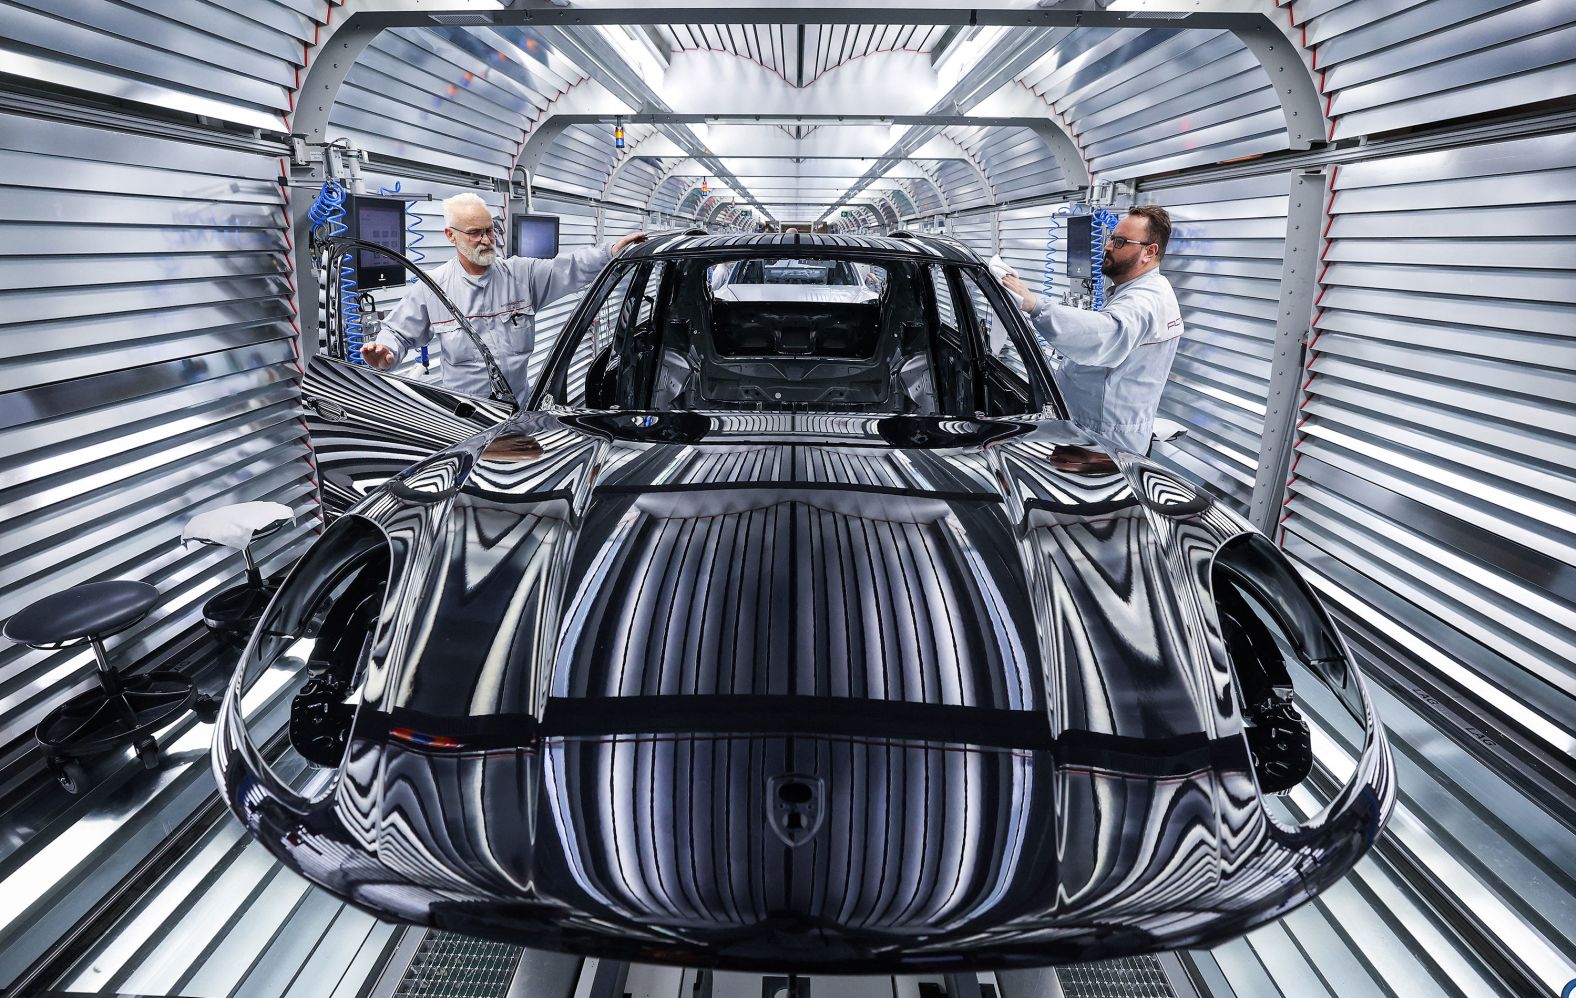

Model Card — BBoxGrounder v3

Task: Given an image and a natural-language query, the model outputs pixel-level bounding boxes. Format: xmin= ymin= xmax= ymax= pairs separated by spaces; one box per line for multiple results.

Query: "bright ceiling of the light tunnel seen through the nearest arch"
xmin=331 ymin=14 xmax=1289 ymax=224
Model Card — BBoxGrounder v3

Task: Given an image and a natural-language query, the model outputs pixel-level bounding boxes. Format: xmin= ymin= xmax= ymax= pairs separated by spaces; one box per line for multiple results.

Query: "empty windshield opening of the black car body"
xmin=544 ymin=251 xmax=1050 ymax=418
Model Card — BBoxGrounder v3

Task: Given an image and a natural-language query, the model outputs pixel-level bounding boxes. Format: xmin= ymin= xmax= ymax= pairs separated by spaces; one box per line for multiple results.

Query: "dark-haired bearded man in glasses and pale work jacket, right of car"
xmin=1001 ymin=205 xmax=1182 ymax=454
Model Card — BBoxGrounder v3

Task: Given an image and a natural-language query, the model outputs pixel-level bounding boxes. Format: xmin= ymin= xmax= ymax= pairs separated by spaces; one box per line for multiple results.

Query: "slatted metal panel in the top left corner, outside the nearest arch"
xmin=0 ymin=0 xmax=328 ymax=131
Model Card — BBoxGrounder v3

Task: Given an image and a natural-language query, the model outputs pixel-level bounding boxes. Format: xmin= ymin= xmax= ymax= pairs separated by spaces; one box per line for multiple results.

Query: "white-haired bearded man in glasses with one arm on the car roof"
xmin=361 ymin=194 xmax=646 ymax=404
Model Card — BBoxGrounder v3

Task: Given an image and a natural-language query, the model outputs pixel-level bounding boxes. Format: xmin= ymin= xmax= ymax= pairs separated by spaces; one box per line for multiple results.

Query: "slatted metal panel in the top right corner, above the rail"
xmin=1292 ymin=0 xmax=1576 ymax=139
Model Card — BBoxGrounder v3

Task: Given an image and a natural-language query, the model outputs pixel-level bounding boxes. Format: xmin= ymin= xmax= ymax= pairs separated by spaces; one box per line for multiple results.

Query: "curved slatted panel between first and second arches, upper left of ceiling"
xmin=328 ymin=28 xmax=532 ymax=177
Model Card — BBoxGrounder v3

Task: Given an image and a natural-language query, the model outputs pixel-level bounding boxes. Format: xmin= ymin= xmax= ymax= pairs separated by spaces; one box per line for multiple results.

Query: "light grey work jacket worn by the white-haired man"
xmin=377 ymin=241 xmax=613 ymax=405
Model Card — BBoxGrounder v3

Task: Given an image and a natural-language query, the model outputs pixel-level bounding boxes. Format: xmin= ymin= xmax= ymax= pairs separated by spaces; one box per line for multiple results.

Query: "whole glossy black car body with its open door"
xmin=214 ymin=235 xmax=1393 ymax=973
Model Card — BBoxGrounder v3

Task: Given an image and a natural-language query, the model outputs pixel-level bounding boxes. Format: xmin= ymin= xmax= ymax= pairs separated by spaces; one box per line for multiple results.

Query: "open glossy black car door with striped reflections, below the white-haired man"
xmin=301 ymin=355 xmax=514 ymax=520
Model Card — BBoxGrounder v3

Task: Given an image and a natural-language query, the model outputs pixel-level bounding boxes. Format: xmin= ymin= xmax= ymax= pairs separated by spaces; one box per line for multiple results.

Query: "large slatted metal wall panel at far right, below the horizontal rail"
xmin=1283 ymin=134 xmax=1576 ymax=757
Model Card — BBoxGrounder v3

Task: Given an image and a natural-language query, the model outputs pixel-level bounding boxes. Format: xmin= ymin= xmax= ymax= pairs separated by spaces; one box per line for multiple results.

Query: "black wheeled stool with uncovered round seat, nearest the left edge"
xmin=5 ymin=582 xmax=219 ymax=793
